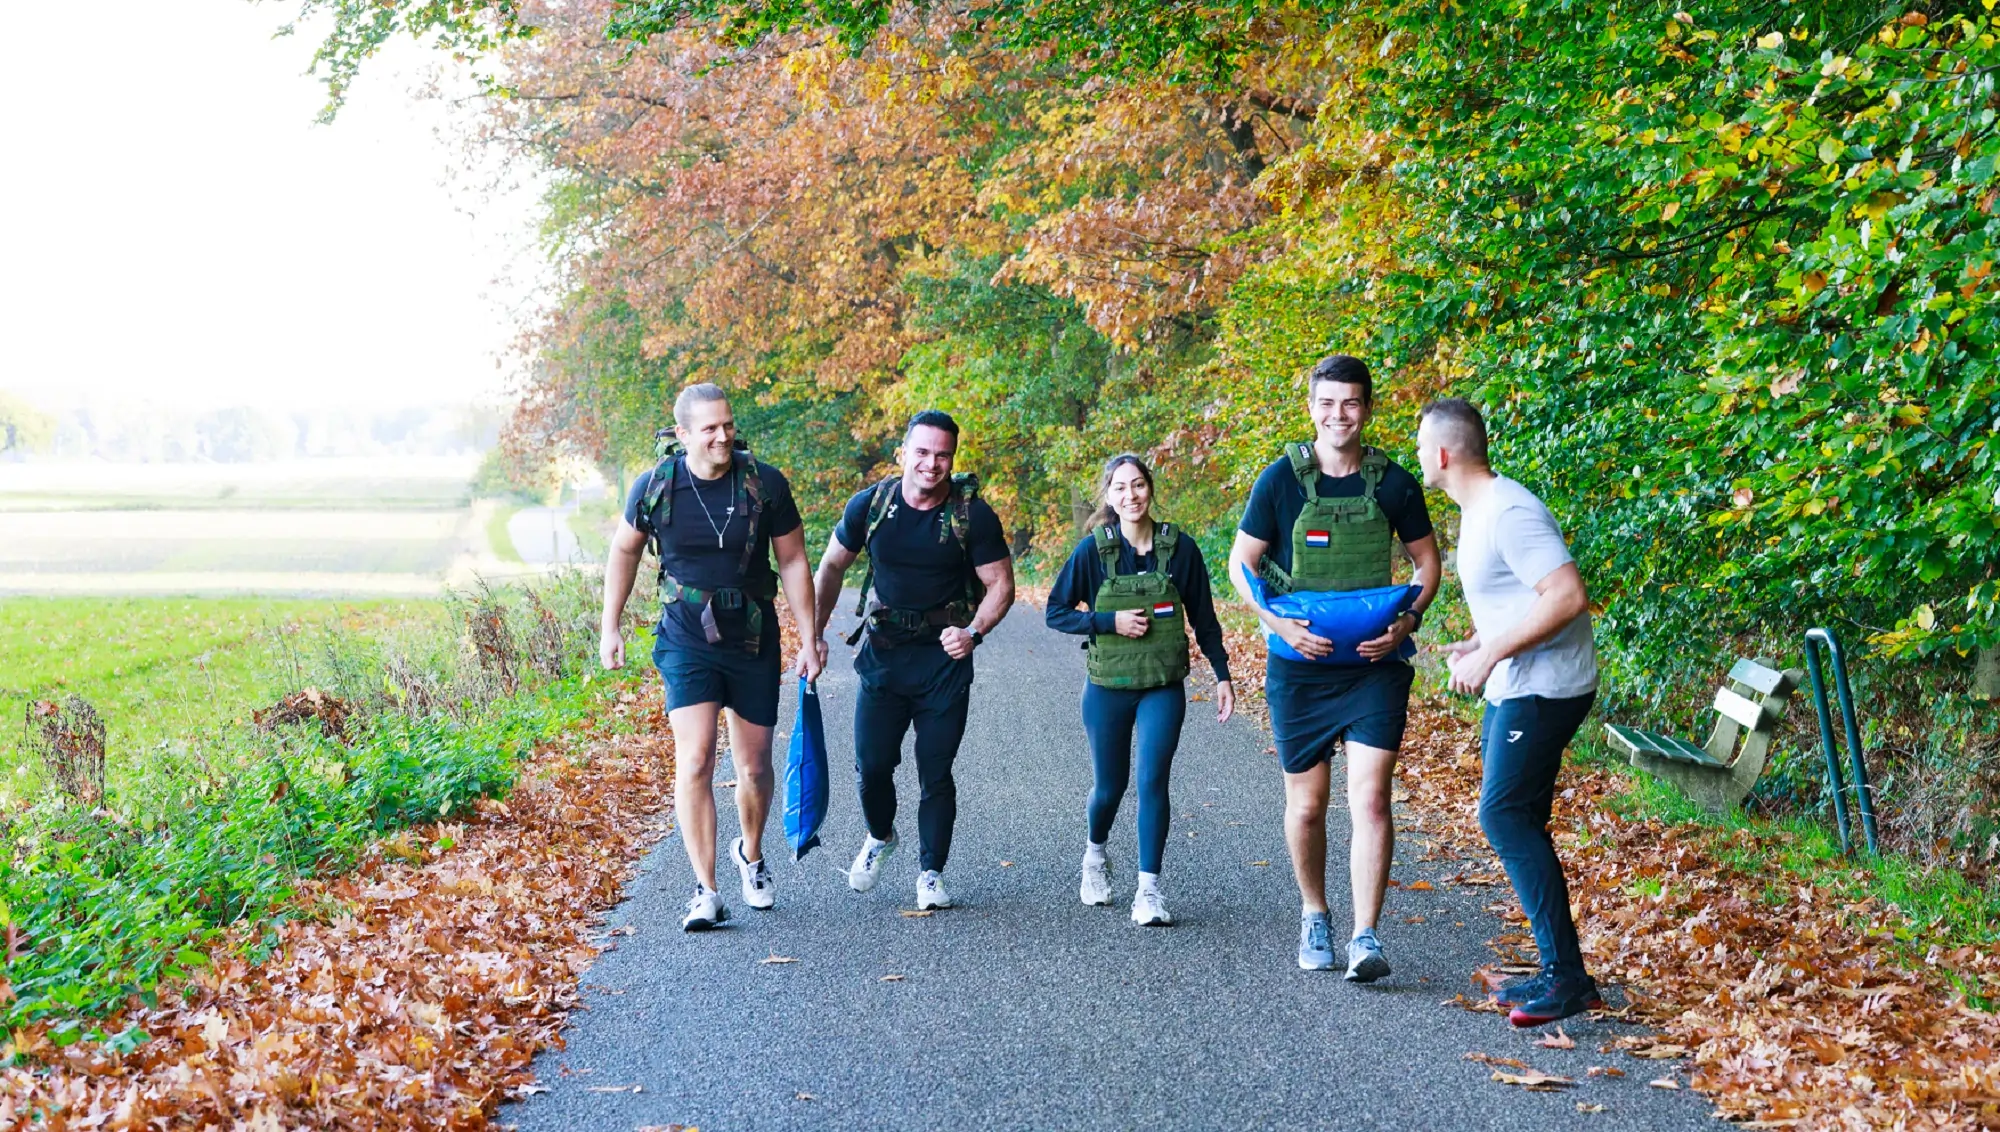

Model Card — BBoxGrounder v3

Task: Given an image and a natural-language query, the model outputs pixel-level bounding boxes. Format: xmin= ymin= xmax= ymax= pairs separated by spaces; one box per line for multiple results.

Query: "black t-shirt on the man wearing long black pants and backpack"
xmin=834 ymin=486 xmax=1008 ymax=610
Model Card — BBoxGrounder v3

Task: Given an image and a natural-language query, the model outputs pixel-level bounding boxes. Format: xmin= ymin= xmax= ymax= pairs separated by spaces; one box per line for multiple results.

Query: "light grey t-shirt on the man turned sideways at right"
xmin=1458 ymin=476 xmax=1598 ymax=704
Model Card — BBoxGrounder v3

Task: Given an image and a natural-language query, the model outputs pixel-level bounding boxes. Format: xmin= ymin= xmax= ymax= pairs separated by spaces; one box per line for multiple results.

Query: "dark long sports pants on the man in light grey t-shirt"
xmin=1480 ymin=692 xmax=1598 ymax=978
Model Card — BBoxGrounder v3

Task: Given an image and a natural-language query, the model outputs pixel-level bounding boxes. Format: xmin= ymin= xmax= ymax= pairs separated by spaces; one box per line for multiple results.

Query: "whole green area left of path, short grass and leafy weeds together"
xmin=0 ymin=574 xmax=644 ymax=1044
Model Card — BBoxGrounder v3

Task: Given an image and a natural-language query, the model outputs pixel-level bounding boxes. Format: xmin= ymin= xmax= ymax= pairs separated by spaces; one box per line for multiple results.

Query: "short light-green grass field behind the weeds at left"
xmin=0 ymin=598 xmax=440 ymax=800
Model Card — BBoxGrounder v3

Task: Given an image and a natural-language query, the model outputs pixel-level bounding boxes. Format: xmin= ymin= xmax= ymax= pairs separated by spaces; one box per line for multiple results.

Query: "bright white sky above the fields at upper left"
xmin=0 ymin=0 xmax=538 ymax=418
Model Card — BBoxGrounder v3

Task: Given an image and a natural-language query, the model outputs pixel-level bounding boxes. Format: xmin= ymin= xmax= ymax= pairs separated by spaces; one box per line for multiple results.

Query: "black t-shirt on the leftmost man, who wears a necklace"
xmin=626 ymin=456 xmax=800 ymax=648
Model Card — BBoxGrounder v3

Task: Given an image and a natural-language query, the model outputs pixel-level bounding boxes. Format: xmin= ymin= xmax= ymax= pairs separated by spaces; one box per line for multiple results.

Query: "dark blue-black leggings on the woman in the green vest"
xmin=1084 ymin=680 xmax=1188 ymax=872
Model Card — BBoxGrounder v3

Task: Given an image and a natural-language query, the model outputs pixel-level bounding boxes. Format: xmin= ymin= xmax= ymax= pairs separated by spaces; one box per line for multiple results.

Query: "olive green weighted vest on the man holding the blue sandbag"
xmin=1258 ymin=442 xmax=1396 ymax=594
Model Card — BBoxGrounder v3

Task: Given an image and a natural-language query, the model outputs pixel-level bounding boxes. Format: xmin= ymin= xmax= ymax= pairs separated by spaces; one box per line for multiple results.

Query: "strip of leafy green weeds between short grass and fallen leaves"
xmin=0 ymin=676 xmax=626 ymax=1044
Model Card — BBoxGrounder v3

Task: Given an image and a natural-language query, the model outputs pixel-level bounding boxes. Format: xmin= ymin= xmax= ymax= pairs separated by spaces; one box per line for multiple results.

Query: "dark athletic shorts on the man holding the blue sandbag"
xmin=1264 ymin=656 xmax=1416 ymax=774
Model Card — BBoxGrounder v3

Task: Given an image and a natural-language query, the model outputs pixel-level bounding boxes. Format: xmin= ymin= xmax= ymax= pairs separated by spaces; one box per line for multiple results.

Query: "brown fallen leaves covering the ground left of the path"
xmin=0 ymin=682 xmax=672 ymax=1132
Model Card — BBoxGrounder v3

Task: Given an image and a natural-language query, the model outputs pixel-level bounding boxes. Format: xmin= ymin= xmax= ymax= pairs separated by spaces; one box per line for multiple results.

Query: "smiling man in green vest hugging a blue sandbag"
xmin=1230 ymin=354 xmax=1440 ymax=982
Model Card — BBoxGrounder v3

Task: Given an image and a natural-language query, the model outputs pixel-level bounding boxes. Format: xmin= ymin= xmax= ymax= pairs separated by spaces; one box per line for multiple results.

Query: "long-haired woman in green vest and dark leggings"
xmin=1046 ymin=452 xmax=1236 ymax=926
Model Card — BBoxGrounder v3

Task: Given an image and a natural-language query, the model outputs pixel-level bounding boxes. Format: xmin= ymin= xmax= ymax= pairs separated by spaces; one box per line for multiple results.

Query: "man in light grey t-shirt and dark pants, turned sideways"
xmin=1416 ymin=398 xmax=1604 ymax=1026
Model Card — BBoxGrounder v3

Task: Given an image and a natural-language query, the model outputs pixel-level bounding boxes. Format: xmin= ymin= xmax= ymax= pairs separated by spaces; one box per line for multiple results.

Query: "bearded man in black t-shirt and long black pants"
xmin=806 ymin=410 xmax=1014 ymax=910
